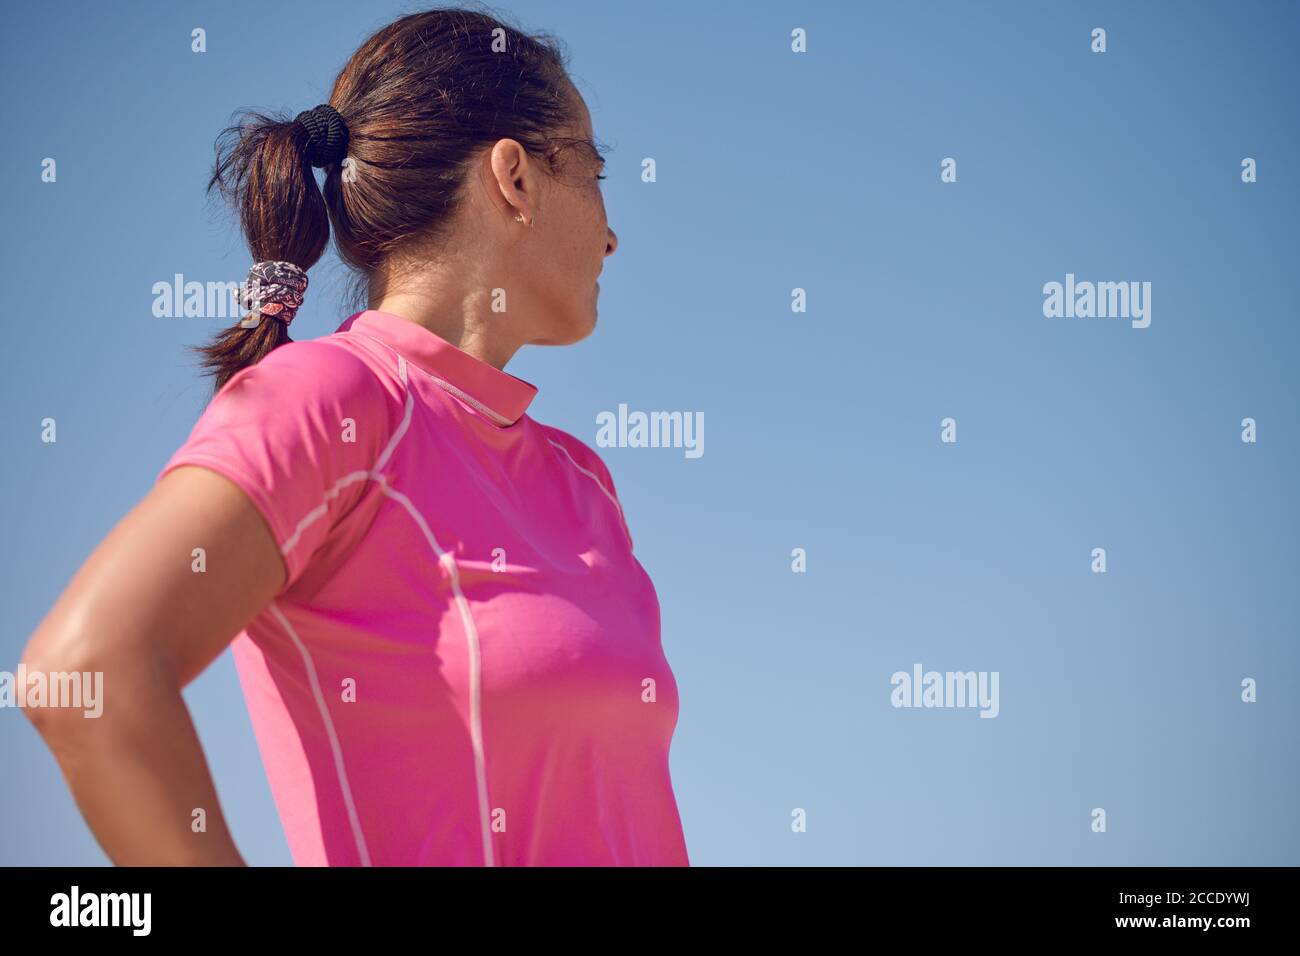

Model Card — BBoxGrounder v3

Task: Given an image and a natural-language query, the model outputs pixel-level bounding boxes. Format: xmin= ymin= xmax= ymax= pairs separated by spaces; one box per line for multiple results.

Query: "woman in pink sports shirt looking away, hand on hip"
xmin=23 ymin=9 xmax=689 ymax=866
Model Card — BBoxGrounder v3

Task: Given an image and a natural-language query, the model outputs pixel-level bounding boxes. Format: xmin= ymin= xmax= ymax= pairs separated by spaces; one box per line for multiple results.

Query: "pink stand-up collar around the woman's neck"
xmin=338 ymin=308 xmax=537 ymax=427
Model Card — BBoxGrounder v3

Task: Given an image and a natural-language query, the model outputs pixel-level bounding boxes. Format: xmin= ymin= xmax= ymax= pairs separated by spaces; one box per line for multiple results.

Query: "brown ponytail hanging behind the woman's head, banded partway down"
xmin=195 ymin=107 xmax=347 ymax=392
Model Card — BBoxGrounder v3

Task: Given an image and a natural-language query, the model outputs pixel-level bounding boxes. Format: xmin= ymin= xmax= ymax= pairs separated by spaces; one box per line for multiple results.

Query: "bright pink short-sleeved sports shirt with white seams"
xmin=159 ymin=310 xmax=689 ymax=866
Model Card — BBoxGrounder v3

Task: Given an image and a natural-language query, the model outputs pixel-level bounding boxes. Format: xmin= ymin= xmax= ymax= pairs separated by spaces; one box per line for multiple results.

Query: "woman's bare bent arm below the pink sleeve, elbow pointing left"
xmin=22 ymin=466 xmax=285 ymax=866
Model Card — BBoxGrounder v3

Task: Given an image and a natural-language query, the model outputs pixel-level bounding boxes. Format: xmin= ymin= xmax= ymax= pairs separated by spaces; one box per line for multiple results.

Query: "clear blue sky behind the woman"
xmin=0 ymin=0 xmax=1300 ymax=865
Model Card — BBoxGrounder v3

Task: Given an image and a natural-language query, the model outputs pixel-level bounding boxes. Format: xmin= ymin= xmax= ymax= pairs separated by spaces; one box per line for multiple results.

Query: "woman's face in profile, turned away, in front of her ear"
xmin=515 ymin=90 xmax=619 ymax=345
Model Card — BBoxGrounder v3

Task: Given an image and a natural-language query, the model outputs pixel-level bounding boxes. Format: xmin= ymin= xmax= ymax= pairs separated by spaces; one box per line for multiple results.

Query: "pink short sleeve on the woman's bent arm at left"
xmin=155 ymin=341 xmax=400 ymax=589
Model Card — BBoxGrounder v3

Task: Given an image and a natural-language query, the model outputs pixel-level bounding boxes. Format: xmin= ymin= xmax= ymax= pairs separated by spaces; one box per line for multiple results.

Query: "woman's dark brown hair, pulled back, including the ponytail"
xmin=196 ymin=7 xmax=588 ymax=392
